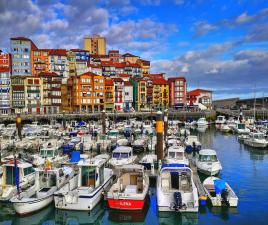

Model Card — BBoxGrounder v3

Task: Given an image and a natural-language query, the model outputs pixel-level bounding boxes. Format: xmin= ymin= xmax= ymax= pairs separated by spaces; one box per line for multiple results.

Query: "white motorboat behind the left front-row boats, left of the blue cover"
xmin=32 ymin=139 xmax=68 ymax=167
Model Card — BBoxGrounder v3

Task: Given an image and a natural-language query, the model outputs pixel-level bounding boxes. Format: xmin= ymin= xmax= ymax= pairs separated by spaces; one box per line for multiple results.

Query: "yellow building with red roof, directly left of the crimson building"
xmin=152 ymin=78 xmax=169 ymax=110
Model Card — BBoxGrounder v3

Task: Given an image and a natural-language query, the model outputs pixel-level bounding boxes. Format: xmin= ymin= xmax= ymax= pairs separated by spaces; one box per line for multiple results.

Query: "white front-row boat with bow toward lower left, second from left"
xmin=10 ymin=167 xmax=77 ymax=215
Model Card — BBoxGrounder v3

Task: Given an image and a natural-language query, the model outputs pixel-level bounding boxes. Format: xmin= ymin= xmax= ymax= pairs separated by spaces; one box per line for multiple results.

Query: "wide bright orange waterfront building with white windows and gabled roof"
xmin=67 ymin=72 xmax=105 ymax=113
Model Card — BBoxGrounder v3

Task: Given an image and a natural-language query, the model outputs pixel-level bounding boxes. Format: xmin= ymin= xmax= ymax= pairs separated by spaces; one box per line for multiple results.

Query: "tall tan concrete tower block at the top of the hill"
xmin=84 ymin=34 xmax=106 ymax=55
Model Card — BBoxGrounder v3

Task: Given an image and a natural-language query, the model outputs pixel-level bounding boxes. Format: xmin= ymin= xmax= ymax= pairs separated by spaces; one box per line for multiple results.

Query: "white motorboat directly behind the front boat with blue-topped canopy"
xmin=165 ymin=146 xmax=189 ymax=166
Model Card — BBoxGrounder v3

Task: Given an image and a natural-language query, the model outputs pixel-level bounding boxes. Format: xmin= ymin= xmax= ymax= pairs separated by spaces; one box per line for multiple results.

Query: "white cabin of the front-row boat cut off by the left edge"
xmin=2 ymin=160 xmax=35 ymax=185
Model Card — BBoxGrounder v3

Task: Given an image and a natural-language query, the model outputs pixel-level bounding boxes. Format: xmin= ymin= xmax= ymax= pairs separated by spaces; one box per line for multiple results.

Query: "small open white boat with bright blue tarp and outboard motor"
xmin=203 ymin=177 xmax=238 ymax=207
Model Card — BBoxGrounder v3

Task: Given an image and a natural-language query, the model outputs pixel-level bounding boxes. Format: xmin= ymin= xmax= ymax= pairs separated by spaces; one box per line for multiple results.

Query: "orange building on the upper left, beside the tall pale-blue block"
xmin=31 ymin=49 xmax=49 ymax=76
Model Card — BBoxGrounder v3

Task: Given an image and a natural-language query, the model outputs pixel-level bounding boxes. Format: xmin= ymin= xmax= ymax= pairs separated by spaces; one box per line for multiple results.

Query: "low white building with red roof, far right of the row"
xmin=187 ymin=89 xmax=212 ymax=109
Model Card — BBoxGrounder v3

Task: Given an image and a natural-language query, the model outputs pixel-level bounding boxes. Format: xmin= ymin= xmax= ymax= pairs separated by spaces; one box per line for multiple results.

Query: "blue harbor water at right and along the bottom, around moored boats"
xmin=0 ymin=126 xmax=268 ymax=225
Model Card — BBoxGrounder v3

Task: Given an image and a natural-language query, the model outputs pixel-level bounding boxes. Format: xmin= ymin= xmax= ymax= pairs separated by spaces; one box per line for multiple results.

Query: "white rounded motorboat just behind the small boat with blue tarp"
xmin=195 ymin=149 xmax=222 ymax=176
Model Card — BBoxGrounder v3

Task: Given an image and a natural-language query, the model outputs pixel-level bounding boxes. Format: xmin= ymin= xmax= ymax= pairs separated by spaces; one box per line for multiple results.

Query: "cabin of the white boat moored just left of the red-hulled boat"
xmin=78 ymin=159 xmax=105 ymax=189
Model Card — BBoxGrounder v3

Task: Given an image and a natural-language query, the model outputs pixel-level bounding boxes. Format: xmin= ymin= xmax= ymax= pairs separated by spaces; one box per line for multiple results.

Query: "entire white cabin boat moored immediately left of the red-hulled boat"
xmin=54 ymin=158 xmax=113 ymax=211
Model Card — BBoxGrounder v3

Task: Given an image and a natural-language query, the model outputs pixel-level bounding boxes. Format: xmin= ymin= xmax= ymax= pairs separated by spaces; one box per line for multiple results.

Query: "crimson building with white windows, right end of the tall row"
xmin=168 ymin=77 xmax=187 ymax=108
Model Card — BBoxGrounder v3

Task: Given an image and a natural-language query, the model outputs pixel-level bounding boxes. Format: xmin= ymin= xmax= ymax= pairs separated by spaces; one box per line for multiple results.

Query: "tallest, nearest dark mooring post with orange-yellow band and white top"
xmin=156 ymin=111 xmax=164 ymax=161
